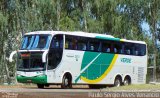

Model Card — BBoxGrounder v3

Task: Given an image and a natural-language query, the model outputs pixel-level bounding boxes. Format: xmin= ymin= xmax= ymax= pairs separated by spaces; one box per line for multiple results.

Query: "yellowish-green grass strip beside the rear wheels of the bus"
xmin=105 ymin=84 xmax=160 ymax=91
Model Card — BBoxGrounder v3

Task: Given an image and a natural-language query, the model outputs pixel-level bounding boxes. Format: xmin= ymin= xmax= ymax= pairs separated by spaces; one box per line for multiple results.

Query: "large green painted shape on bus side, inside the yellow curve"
xmin=75 ymin=52 xmax=115 ymax=83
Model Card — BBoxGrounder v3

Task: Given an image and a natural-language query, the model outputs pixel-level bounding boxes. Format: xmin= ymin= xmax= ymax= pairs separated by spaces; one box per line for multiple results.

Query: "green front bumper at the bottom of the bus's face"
xmin=17 ymin=75 xmax=47 ymax=84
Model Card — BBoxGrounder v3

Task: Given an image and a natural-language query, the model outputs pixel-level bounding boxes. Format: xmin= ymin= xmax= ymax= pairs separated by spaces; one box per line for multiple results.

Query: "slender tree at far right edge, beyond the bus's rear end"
xmin=144 ymin=0 xmax=160 ymax=81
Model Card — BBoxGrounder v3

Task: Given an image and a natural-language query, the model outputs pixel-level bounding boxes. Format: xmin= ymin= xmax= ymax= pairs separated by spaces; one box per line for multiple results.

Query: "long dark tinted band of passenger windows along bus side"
xmin=65 ymin=35 xmax=146 ymax=56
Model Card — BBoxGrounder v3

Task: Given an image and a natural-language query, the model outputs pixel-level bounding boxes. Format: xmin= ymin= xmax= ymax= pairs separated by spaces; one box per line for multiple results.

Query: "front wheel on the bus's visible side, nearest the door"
xmin=61 ymin=75 xmax=72 ymax=89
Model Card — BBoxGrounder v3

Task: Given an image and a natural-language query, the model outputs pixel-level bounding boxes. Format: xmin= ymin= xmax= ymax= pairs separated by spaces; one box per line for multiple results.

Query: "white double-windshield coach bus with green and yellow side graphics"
xmin=9 ymin=31 xmax=147 ymax=88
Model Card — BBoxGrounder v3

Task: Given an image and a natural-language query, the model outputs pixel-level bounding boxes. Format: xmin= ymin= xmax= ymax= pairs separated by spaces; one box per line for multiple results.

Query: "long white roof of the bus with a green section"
xmin=25 ymin=31 xmax=146 ymax=44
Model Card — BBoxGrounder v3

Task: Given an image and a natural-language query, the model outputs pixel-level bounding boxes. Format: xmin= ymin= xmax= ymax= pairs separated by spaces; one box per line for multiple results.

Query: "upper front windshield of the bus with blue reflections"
xmin=21 ymin=35 xmax=51 ymax=50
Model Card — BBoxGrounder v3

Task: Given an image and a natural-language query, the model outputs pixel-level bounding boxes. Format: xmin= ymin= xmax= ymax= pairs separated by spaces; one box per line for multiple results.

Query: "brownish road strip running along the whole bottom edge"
xmin=0 ymin=87 xmax=160 ymax=98
